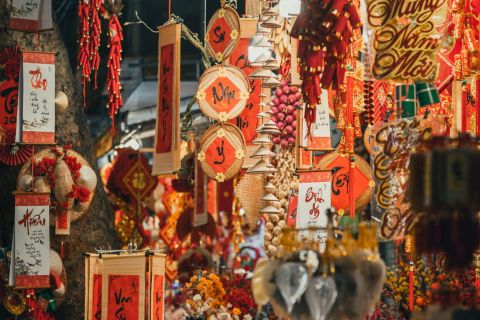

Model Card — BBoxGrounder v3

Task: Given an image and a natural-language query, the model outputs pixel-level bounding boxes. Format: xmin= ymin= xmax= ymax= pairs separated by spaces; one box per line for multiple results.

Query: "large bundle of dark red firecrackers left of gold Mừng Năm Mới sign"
xmin=291 ymin=0 xmax=361 ymax=127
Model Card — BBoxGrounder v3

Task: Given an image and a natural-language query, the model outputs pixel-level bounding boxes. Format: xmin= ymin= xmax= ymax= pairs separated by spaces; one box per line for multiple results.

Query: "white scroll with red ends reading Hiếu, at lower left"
xmin=9 ymin=193 xmax=50 ymax=288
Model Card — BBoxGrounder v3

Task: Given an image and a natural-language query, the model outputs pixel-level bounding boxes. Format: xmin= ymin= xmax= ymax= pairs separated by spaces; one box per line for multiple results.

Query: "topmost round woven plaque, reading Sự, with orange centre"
xmin=205 ymin=7 xmax=240 ymax=62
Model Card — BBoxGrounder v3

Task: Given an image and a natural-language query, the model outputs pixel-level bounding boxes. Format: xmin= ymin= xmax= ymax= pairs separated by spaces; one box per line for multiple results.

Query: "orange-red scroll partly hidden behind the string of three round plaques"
xmin=230 ymin=18 xmax=262 ymax=169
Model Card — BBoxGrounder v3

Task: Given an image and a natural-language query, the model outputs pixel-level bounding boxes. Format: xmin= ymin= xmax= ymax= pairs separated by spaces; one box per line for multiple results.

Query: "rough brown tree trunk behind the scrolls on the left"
xmin=0 ymin=0 xmax=118 ymax=320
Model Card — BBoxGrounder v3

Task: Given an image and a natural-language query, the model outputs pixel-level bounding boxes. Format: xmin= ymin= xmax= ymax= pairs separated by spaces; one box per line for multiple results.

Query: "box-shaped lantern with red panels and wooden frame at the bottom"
xmin=85 ymin=252 xmax=166 ymax=320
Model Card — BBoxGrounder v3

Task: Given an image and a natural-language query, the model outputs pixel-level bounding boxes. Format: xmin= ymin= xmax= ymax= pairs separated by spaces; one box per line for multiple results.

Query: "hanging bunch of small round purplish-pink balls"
xmin=271 ymin=80 xmax=302 ymax=148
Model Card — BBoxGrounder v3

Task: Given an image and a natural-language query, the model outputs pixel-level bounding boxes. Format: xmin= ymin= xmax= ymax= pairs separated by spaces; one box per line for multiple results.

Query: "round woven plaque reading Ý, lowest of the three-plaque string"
xmin=197 ymin=123 xmax=245 ymax=182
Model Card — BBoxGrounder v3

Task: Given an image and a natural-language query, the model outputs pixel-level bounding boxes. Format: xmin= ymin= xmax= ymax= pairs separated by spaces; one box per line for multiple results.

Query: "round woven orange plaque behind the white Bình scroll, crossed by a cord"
xmin=317 ymin=152 xmax=375 ymax=214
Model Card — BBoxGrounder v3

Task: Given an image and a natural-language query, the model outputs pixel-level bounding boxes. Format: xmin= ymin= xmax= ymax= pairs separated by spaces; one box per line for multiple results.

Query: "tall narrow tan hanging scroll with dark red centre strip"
xmin=152 ymin=23 xmax=181 ymax=176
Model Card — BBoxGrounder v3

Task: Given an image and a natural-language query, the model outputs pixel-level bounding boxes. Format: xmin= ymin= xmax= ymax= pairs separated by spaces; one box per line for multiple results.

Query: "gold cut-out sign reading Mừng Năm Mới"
xmin=366 ymin=0 xmax=448 ymax=81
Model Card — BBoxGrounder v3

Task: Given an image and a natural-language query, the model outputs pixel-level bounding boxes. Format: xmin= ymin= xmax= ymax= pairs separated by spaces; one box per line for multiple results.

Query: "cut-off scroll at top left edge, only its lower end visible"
xmin=8 ymin=0 xmax=53 ymax=32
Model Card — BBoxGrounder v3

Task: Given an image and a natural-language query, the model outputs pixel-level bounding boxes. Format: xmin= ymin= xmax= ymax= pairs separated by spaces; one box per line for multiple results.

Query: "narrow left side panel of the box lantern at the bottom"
xmin=85 ymin=254 xmax=103 ymax=320
